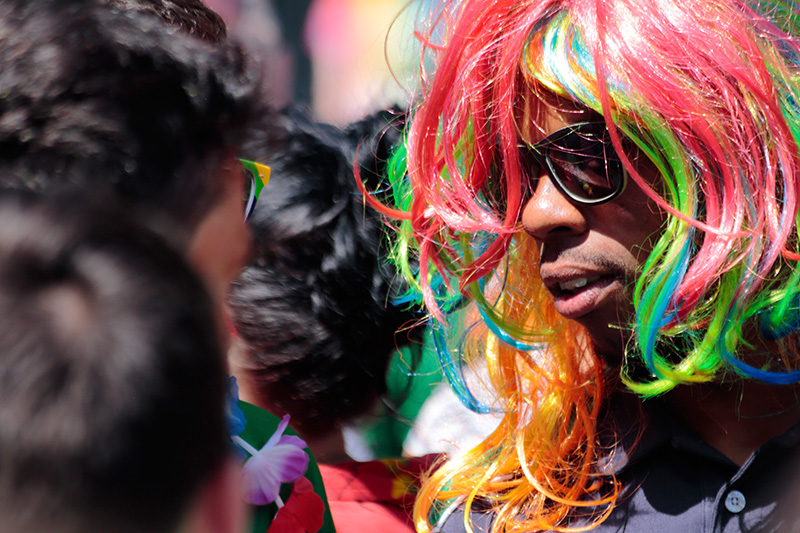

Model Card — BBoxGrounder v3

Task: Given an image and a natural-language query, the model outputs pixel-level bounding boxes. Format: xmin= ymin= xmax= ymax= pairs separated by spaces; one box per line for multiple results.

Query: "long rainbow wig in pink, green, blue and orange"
xmin=364 ymin=0 xmax=800 ymax=532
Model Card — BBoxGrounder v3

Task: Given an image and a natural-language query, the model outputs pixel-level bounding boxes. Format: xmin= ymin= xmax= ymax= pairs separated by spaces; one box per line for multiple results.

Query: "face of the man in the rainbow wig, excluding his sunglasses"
xmin=520 ymin=97 xmax=664 ymax=362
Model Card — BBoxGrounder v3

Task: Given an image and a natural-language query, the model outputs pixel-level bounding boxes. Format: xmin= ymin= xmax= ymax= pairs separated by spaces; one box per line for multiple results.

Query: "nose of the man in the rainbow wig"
xmin=522 ymin=172 xmax=588 ymax=242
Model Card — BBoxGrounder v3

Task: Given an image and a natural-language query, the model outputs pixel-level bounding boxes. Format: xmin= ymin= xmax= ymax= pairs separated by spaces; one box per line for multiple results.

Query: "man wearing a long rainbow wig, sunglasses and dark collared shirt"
xmin=370 ymin=0 xmax=800 ymax=532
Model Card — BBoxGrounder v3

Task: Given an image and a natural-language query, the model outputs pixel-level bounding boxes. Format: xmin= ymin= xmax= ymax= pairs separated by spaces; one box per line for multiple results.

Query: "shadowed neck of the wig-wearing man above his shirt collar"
xmin=666 ymin=380 xmax=800 ymax=465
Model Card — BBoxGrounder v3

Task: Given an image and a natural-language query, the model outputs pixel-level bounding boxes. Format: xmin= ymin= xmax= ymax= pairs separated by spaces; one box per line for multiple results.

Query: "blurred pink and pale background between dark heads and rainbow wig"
xmin=206 ymin=0 xmax=423 ymax=125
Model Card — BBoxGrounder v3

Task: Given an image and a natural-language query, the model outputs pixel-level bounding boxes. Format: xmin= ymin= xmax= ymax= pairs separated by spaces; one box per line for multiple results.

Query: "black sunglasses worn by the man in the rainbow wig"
xmin=522 ymin=121 xmax=628 ymax=205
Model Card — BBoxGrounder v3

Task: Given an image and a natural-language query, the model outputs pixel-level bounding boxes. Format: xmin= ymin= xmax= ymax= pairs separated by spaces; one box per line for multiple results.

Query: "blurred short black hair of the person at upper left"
xmin=0 ymin=0 xmax=261 ymax=239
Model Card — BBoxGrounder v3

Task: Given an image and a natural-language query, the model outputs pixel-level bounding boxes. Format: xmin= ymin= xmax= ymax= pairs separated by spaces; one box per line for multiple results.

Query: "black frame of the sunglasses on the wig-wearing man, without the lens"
xmin=525 ymin=120 xmax=628 ymax=205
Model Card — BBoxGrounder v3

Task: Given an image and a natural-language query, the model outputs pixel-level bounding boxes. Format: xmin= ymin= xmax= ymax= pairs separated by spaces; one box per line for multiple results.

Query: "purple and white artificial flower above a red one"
xmin=233 ymin=415 xmax=309 ymax=507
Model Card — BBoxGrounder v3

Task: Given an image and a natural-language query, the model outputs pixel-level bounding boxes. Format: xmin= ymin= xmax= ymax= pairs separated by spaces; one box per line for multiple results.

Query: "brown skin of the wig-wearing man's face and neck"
xmin=520 ymin=99 xmax=800 ymax=465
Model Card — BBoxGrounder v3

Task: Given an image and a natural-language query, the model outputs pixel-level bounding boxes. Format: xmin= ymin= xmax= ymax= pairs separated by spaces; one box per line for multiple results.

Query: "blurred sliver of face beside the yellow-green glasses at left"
xmin=188 ymin=156 xmax=252 ymax=342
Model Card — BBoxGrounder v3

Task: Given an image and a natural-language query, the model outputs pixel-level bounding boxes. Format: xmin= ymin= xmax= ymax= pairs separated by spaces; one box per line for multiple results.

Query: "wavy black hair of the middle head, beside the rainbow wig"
xmin=230 ymin=108 xmax=419 ymax=437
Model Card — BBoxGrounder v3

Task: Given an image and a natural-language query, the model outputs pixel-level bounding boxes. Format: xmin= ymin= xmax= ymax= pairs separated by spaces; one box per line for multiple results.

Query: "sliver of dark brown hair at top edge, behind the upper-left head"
xmin=97 ymin=0 xmax=227 ymax=43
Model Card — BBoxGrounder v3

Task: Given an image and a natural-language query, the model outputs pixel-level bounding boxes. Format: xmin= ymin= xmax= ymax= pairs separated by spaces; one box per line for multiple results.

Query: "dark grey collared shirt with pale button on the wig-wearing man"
xmin=440 ymin=394 xmax=800 ymax=533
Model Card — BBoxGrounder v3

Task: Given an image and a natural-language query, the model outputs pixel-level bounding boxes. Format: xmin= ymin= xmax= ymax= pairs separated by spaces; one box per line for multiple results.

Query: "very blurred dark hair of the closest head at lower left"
xmin=0 ymin=191 xmax=228 ymax=533
